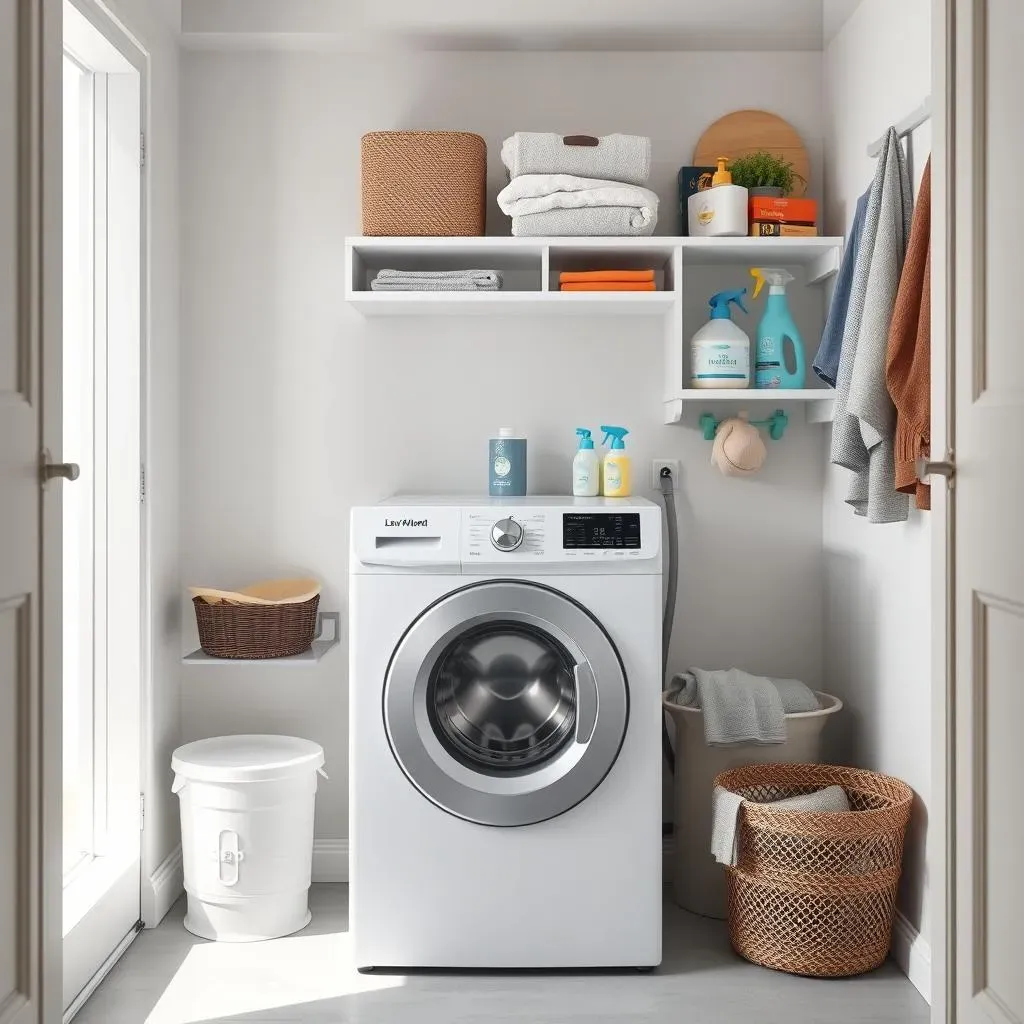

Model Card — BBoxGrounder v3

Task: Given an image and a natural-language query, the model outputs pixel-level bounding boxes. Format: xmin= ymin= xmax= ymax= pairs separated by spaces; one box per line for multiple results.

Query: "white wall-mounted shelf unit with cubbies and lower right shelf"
xmin=345 ymin=237 xmax=843 ymax=427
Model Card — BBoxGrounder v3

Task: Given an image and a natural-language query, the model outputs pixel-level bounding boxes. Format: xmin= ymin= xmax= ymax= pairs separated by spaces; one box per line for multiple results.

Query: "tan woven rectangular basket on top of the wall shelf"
xmin=361 ymin=131 xmax=487 ymax=234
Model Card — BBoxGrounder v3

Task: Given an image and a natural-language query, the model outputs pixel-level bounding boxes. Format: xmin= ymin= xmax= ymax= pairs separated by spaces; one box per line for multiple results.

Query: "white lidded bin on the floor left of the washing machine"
xmin=171 ymin=736 xmax=327 ymax=942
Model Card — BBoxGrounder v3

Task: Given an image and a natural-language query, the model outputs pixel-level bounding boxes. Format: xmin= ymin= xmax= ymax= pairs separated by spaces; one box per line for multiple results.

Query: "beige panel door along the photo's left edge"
xmin=0 ymin=0 xmax=61 ymax=1024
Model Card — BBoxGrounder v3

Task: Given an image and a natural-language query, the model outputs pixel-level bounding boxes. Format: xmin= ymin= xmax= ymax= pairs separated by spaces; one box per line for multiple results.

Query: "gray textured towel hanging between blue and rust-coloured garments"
xmin=831 ymin=128 xmax=912 ymax=523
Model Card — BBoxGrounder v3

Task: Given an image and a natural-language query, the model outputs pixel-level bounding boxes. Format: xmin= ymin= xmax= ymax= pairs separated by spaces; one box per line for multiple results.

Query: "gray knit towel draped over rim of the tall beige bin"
xmin=669 ymin=669 xmax=818 ymax=746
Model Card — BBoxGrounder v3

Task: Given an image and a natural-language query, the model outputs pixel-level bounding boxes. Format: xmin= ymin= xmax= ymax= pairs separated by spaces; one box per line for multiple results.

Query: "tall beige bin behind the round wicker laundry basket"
xmin=662 ymin=691 xmax=843 ymax=919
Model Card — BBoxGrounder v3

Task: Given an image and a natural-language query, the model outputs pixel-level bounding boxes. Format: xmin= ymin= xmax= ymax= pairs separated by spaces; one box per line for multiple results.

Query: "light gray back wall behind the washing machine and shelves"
xmin=181 ymin=52 xmax=824 ymax=839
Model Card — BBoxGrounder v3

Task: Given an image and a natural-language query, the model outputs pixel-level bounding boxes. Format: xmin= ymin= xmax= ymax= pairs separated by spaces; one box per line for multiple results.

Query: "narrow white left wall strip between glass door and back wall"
xmin=99 ymin=0 xmax=181 ymax=925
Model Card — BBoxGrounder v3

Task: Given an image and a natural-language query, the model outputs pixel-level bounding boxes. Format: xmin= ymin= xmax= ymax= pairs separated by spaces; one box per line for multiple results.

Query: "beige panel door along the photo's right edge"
xmin=953 ymin=0 xmax=1024 ymax=1024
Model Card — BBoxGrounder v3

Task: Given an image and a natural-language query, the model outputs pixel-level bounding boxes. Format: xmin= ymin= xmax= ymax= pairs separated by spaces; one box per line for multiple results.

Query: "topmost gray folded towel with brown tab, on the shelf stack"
xmin=502 ymin=131 xmax=650 ymax=185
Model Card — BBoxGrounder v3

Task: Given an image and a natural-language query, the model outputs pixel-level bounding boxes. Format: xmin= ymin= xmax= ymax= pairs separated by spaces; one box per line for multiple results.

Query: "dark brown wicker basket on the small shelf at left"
xmin=193 ymin=594 xmax=319 ymax=658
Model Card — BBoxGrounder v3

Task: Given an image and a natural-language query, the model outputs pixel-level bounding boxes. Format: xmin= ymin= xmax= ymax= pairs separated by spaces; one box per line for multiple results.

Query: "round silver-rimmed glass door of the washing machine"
xmin=384 ymin=581 xmax=629 ymax=826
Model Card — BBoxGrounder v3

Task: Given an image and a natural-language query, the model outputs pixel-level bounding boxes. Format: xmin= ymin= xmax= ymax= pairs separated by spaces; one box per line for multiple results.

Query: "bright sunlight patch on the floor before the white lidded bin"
xmin=144 ymin=932 xmax=404 ymax=1024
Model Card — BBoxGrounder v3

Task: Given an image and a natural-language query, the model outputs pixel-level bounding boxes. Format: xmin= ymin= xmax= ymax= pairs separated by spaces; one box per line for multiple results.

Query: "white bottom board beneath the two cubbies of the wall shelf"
xmin=348 ymin=292 xmax=675 ymax=316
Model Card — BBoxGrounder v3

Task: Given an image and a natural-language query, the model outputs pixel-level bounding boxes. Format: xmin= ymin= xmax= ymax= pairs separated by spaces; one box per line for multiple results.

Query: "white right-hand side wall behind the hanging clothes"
xmin=823 ymin=0 xmax=931 ymax=939
